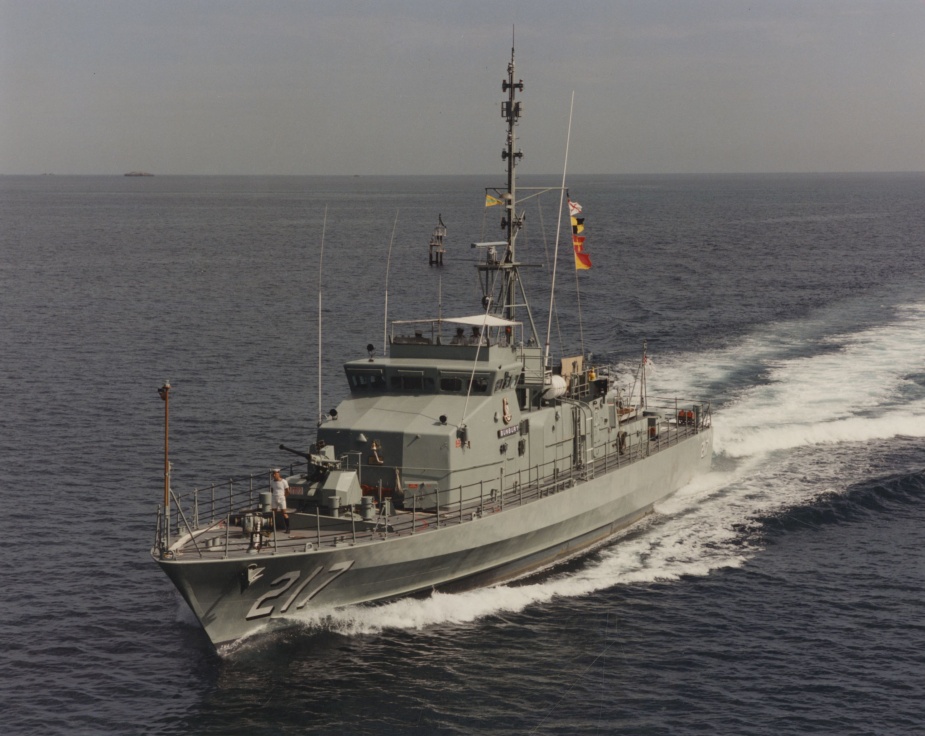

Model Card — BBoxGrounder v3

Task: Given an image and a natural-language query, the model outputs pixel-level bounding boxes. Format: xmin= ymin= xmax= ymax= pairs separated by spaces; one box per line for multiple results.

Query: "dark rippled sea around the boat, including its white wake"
xmin=0 ymin=174 xmax=925 ymax=736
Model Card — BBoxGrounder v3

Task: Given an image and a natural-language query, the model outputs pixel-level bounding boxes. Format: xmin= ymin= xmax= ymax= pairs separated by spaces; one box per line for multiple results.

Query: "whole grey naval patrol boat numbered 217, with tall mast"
xmin=152 ymin=49 xmax=713 ymax=647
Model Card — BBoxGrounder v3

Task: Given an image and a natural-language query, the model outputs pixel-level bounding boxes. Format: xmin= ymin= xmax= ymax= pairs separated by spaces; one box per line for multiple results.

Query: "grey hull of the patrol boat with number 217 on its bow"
xmin=158 ymin=427 xmax=712 ymax=645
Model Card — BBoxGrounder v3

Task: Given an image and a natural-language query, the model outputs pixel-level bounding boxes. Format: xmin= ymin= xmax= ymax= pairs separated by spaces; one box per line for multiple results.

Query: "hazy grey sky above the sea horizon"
xmin=0 ymin=0 xmax=925 ymax=174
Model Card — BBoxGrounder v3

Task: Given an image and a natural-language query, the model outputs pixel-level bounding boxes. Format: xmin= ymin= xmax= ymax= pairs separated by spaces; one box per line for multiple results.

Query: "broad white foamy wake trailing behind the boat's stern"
xmin=659 ymin=305 xmax=925 ymax=458
